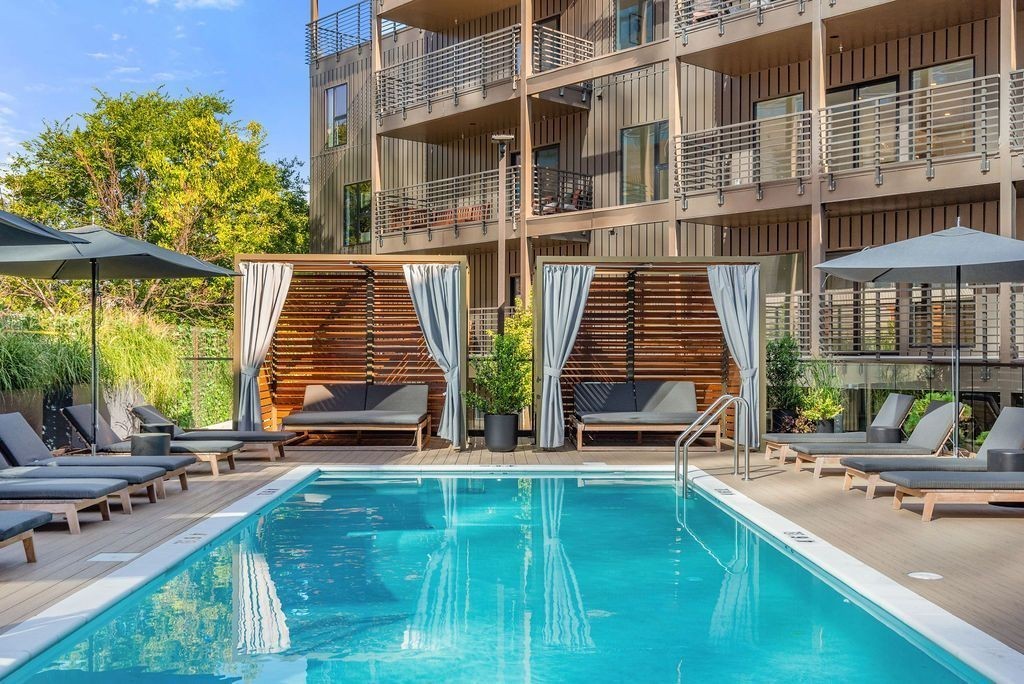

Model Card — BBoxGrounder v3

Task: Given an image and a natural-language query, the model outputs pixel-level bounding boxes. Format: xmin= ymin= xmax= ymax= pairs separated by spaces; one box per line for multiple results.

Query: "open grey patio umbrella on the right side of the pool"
xmin=816 ymin=223 xmax=1024 ymax=455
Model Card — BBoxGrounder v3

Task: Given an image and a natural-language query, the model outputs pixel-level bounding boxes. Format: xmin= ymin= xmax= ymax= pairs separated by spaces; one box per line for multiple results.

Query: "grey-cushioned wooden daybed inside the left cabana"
xmin=282 ymin=382 xmax=430 ymax=451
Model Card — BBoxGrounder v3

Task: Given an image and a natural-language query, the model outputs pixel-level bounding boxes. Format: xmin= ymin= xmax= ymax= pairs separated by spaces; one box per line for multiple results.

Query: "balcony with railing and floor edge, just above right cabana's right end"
xmin=676 ymin=112 xmax=811 ymax=219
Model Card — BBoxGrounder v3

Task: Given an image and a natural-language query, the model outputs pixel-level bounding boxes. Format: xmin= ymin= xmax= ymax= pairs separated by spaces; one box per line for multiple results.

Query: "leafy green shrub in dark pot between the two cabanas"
xmin=466 ymin=308 xmax=534 ymax=452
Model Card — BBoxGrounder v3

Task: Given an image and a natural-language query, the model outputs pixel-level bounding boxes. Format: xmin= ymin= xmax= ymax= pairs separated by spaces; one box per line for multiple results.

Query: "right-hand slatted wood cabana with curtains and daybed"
xmin=534 ymin=257 xmax=765 ymax=450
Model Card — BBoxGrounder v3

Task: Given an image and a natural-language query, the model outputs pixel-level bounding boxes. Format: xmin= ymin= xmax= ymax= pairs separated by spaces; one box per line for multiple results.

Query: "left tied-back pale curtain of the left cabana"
xmin=239 ymin=261 xmax=292 ymax=430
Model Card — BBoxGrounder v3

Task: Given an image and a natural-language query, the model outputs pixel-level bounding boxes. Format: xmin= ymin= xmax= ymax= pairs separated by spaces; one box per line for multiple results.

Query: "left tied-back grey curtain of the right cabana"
xmin=540 ymin=265 xmax=594 ymax=448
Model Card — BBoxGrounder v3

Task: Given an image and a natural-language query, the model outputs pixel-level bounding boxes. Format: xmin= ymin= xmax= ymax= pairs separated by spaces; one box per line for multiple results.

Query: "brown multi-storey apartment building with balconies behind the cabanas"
xmin=307 ymin=0 xmax=1024 ymax=428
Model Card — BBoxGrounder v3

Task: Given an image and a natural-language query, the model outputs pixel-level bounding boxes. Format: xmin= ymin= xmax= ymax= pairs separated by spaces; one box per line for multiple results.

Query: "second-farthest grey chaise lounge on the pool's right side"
xmin=790 ymin=403 xmax=963 ymax=477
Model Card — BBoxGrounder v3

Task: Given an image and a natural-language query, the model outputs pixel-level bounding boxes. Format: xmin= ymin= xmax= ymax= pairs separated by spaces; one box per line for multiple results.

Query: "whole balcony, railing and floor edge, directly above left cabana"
xmin=374 ymin=167 xmax=519 ymax=252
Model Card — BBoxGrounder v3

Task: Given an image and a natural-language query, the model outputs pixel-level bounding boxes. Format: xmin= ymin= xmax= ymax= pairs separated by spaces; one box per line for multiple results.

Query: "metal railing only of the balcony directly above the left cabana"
xmin=374 ymin=167 xmax=519 ymax=244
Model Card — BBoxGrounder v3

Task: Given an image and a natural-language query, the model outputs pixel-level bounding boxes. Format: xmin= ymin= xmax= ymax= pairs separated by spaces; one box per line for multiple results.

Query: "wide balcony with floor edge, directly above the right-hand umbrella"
xmin=821 ymin=76 xmax=999 ymax=202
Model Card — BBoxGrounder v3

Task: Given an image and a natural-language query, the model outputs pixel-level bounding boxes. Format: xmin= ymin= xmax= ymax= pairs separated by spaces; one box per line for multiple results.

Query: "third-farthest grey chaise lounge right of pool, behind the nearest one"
xmin=840 ymin=407 xmax=1024 ymax=499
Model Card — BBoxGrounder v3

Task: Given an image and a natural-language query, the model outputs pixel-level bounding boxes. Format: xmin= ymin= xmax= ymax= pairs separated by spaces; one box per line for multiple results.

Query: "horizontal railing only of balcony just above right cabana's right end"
xmin=676 ymin=112 xmax=811 ymax=196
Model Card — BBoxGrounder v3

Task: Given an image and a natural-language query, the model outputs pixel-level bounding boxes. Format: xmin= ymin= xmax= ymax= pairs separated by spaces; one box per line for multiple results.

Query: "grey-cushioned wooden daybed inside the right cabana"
xmin=573 ymin=380 xmax=722 ymax=451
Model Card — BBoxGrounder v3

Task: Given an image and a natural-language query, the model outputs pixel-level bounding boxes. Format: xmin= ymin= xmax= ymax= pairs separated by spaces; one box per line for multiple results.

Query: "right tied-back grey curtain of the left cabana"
xmin=402 ymin=263 xmax=466 ymax=446
